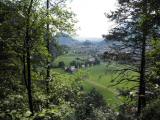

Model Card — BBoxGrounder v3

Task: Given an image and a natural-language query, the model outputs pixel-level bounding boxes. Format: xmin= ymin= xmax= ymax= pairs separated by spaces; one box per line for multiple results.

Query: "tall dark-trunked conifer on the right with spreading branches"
xmin=103 ymin=0 xmax=160 ymax=114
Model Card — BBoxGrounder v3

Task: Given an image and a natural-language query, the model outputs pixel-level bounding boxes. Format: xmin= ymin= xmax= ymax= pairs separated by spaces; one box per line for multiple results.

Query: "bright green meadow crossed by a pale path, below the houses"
xmin=83 ymin=63 xmax=121 ymax=106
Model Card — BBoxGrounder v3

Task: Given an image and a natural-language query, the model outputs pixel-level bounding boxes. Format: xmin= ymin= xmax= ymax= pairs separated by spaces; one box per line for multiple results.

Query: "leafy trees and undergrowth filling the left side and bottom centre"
xmin=0 ymin=0 xmax=114 ymax=120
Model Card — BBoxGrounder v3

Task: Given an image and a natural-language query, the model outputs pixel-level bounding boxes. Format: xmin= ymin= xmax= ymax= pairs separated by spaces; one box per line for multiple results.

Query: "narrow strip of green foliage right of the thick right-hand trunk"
xmin=147 ymin=38 xmax=160 ymax=103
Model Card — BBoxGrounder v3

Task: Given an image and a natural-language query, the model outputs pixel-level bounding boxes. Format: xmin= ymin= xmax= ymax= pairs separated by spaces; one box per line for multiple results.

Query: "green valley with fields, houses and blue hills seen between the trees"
xmin=54 ymin=35 xmax=136 ymax=107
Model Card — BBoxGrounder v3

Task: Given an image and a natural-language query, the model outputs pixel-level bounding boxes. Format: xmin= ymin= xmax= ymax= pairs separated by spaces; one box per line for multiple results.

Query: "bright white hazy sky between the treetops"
xmin=70 ymin=0 xmax=116 ymax=38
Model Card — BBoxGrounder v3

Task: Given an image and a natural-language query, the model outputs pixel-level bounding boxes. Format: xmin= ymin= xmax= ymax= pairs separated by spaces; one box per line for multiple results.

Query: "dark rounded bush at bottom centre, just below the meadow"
xmin=75 ymin=89 xmax=116 ymax=120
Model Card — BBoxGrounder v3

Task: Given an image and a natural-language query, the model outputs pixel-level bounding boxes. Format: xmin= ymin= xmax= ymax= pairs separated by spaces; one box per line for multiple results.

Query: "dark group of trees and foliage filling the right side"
xmin=103 ymin=0 xmax=160 ymax=120
